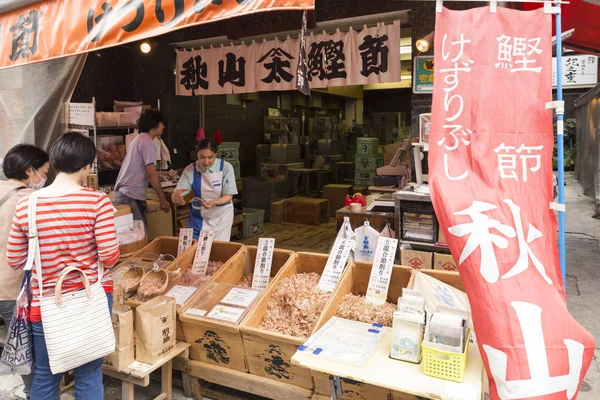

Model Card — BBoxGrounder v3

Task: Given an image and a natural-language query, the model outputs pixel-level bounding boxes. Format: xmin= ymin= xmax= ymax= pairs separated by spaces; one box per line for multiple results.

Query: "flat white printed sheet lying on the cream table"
xmin=298 ymin=317 xmax=387 ymax=366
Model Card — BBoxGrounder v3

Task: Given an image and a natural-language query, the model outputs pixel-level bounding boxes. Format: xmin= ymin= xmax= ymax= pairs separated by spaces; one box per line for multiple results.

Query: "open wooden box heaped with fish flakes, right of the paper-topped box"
xmin=240 ymin=253 xmax=348 ymax=390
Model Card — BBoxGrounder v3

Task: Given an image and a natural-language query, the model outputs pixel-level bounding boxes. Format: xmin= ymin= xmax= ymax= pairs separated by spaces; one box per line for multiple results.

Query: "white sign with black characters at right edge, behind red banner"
xmin=552 ymin=55 xmax=598 ymax=88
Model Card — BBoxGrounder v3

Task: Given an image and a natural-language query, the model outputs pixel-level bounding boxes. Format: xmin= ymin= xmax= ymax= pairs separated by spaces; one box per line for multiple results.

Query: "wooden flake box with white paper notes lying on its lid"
xmin=180 ymin=246 xmax=294 ymax=378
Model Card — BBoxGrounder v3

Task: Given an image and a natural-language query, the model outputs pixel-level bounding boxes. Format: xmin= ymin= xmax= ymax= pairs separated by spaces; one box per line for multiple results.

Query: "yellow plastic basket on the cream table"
xmin=421 ymin=329 xmax=471 ymax=382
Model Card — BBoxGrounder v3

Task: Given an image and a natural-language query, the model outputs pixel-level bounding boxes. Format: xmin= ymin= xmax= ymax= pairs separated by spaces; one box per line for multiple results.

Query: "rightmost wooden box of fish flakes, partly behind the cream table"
xmin=312 ymin=262 xmax=412 ymax=400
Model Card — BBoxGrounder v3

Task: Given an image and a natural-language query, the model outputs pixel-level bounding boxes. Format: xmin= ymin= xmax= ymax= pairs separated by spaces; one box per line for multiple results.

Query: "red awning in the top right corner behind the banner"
xmin=518 ymin=0 xmax=600 ymax=56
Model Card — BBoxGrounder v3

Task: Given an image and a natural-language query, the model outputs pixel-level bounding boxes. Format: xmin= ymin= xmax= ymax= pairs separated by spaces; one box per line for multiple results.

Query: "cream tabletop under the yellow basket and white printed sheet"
xmin=292 ymin=329 xmax=484 ymax=400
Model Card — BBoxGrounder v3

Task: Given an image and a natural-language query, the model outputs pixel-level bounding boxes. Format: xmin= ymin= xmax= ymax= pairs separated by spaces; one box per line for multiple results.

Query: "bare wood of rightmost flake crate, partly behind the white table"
xmin=312 ymin=262 xmax=412 ymax=400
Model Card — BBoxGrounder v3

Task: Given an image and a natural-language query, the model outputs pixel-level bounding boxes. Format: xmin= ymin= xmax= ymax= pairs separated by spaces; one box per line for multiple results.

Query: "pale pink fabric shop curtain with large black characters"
xmin=176 ymin=21 xmax=400 ymax=96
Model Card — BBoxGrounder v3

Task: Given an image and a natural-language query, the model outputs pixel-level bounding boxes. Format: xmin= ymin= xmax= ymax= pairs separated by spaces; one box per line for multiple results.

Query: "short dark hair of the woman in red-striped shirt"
xmin=50 ymin=132 xmax=96 ymax=174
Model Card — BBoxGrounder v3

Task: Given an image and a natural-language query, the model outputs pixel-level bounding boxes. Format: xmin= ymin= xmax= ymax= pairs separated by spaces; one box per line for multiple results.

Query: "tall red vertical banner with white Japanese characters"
xmin=429 ymin=7 xmax=594 ymax=399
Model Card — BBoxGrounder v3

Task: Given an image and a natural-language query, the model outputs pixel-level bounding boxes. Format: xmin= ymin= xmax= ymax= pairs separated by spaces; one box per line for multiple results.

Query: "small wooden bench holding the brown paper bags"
xmin=102 ymin=342 xmax=190 ymax=400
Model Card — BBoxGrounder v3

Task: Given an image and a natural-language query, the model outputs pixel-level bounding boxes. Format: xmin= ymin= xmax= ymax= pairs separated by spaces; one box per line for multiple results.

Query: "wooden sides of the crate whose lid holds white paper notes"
xmin=180 ymin=246 xmax=294 ymax=372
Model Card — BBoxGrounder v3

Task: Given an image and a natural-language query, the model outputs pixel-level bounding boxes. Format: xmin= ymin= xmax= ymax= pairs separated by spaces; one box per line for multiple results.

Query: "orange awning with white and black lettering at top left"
xmin=0 ymin=0 xmax=315 ymax=69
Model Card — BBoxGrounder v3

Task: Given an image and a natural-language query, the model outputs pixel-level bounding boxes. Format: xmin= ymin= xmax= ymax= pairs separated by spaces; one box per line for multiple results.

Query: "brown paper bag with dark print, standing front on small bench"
xmin=135 ymin=296 xmax=176 ymax=364
